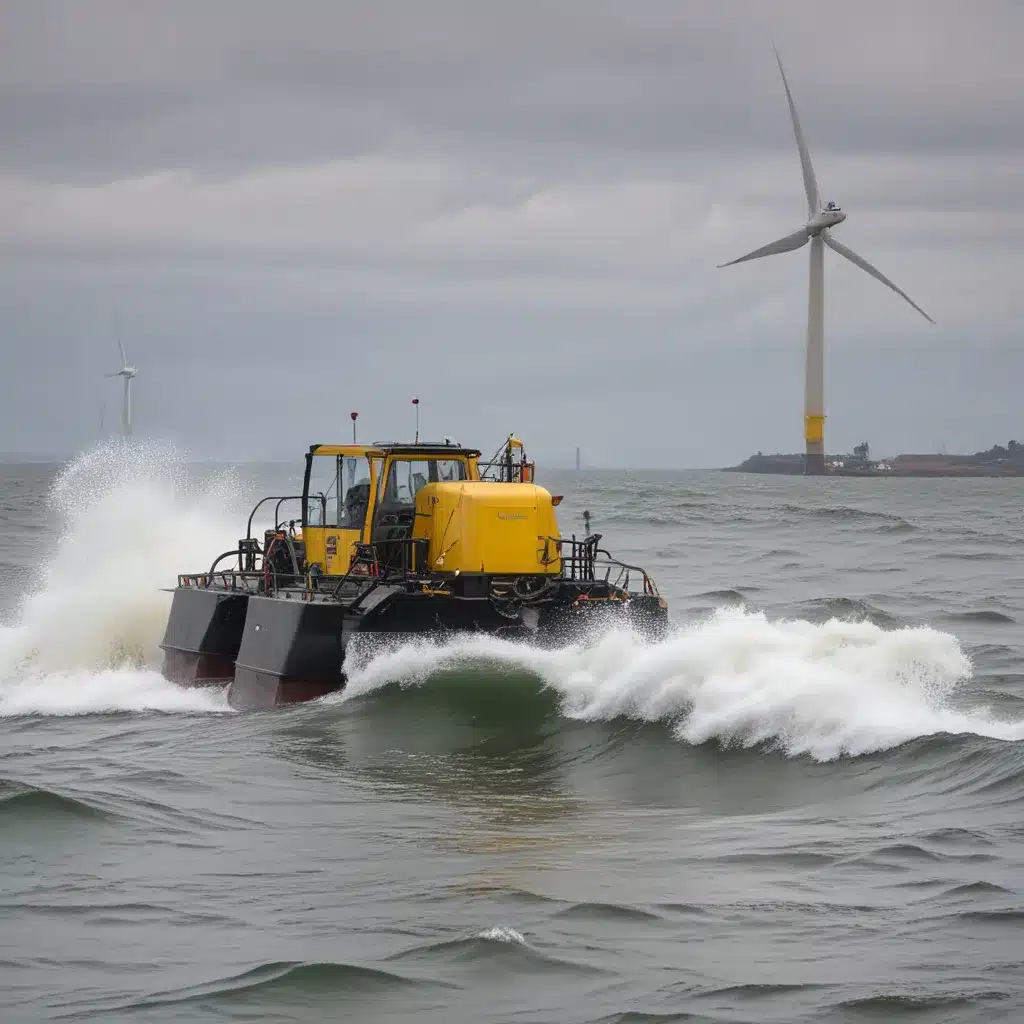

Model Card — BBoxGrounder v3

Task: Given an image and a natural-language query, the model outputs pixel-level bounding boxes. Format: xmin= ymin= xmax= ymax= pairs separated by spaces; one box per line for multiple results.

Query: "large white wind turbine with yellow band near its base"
xmin=719 ymin=49 xmax=935 ymax=474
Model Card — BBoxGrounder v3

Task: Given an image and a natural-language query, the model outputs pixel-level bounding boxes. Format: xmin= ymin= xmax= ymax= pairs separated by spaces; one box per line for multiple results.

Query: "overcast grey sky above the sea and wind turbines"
xmin=0 ymin=0 xmax=1024 ymax=467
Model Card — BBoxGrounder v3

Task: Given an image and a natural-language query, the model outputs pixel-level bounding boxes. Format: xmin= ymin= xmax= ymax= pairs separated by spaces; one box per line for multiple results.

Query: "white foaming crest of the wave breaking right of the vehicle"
xmin=341 ymin=608 xmax=1024 ymax=761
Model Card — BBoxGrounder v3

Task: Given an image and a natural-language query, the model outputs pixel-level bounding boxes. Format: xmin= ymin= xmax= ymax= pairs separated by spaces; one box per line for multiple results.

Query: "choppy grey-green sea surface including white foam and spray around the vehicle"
xmin=0 ymin=444 xmax=1024 ymax=1024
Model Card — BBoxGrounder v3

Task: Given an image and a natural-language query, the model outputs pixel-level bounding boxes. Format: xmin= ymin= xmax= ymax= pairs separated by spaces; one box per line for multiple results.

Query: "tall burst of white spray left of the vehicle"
xmin=0 ymin=440 xmax=249 ymax=714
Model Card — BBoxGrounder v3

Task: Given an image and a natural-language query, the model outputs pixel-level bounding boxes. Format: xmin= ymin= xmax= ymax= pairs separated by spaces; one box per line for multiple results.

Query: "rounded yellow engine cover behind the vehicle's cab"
xmin=413 ymin=481 xmax=561 ymax=575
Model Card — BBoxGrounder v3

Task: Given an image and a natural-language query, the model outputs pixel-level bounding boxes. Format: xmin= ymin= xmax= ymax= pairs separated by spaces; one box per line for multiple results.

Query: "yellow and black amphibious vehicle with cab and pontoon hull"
xmin=161 ymin=435 xmax=668 ymax=708
